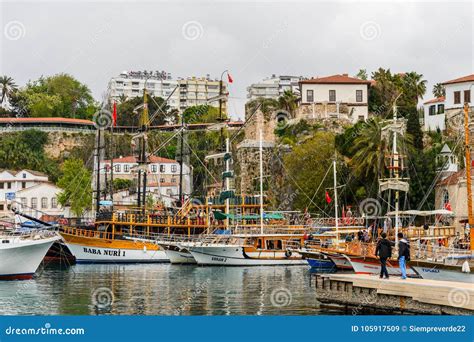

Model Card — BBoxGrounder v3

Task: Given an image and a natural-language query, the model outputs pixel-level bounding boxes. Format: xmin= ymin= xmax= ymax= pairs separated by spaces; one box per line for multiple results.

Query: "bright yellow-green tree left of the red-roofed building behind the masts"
xmin=57 ymin=159 xmax=92 ymax=217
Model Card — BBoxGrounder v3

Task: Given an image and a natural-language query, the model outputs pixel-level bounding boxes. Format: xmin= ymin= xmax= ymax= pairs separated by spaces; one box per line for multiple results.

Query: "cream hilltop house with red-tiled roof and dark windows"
xmin=297 ymin=74 xmax=370 ymax=123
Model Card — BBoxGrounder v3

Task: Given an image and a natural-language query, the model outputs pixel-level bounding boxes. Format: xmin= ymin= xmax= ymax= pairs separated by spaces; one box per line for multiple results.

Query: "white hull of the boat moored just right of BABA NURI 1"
xmin=189 ymin=245 xmax=306 ymax=266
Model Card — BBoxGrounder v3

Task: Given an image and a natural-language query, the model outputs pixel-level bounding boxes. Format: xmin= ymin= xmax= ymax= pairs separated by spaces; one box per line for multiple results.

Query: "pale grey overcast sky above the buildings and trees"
xmin=0 ymin=0 xmax=474 ymax=118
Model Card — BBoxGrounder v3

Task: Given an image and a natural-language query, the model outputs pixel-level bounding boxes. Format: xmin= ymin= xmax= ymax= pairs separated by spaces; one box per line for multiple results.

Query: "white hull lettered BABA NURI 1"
xmin=66 ymin=242 xmax=169 ymax=263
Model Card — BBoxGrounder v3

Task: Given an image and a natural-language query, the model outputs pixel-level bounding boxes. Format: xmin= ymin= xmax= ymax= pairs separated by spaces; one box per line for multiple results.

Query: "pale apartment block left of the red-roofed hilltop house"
xmin=247 ymin=75 xmax=303 ymax=101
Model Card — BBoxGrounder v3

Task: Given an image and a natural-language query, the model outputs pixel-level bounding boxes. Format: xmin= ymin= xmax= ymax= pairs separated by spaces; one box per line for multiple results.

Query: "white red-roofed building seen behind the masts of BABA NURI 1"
xmin=100 ymin=156 xmax=193 ymax=204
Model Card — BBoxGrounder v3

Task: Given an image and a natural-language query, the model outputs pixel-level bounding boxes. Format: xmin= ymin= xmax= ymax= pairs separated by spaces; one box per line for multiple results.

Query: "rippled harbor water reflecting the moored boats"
xmin=0 ymin=264 xmax=331 ymax=315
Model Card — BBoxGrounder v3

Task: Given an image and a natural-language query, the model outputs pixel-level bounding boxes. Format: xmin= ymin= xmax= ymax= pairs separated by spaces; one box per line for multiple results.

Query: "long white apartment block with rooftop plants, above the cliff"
xmin=108 ymin=71 xmax=227 ymax=111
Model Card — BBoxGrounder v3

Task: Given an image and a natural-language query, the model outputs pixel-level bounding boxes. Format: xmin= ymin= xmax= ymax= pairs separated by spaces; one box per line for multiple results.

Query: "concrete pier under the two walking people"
xmin=313 ymin=274 xmax=474 ymax=315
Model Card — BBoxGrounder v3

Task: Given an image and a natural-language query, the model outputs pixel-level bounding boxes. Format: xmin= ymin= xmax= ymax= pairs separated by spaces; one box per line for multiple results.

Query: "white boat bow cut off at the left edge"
xmin=0 ymin=236 xmax=60 ymax=280
